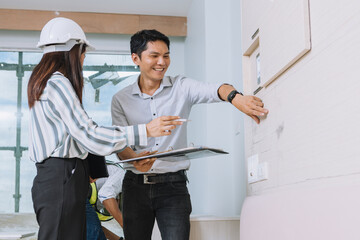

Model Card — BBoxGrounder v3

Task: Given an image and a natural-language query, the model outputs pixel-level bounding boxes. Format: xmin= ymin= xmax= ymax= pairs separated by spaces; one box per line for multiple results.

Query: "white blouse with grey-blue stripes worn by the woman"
xmin=29 ymin=72 xmax=147 ymax=162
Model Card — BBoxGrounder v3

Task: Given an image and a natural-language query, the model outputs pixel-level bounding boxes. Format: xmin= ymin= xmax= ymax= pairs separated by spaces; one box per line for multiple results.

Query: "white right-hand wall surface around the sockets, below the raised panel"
xmin=244 ymin=0 xmax=360 ymax=195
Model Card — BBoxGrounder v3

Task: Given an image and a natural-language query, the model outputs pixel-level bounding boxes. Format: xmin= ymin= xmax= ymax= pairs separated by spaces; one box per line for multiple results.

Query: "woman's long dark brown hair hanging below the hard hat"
xmin=27 ymin=44 xmax=86 ymax=108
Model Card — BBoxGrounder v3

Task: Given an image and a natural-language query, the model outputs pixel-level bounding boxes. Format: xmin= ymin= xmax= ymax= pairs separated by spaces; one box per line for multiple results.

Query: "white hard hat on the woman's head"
xmin=36 ymin=17 xmax=95 ymax=53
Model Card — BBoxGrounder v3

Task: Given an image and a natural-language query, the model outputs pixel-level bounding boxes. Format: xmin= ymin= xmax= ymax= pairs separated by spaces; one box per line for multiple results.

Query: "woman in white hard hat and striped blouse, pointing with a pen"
xmin=28 ymin=18 xmax=179 ymax=240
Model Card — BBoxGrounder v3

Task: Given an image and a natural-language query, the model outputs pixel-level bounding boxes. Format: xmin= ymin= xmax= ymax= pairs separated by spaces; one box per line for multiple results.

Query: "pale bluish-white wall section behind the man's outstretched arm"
xmin=185 ymin=0 xmax=246 ymax=216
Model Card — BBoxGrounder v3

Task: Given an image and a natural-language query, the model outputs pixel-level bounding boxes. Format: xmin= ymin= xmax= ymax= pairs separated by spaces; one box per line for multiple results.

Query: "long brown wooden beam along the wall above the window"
xmin=0 ymin=9 xmax=187 ymax=37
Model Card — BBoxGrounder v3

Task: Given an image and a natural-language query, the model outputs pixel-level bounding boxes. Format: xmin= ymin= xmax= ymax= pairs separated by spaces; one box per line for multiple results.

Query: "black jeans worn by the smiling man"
xmin=122 ymin=171 xmax=192 ymax=240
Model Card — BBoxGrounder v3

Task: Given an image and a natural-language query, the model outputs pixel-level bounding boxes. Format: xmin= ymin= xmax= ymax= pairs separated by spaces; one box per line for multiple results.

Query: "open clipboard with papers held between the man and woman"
xmin=119 ymin=146 xmax=229 ymax=163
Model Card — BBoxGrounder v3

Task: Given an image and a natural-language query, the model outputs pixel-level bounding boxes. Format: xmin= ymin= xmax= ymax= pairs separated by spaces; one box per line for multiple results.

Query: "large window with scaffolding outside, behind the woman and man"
xmin=0 ymin=51 xmax=139 ymax=213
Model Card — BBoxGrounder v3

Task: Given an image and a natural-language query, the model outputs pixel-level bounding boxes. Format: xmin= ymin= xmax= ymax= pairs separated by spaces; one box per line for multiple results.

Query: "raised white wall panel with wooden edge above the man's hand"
xmin=259 ymin=0 xmax=310 ymax=86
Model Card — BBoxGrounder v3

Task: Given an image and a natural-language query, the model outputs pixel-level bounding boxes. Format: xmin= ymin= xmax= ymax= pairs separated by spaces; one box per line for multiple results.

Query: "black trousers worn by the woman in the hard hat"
xmin=31 ymin=158 xmax=89 ymax=240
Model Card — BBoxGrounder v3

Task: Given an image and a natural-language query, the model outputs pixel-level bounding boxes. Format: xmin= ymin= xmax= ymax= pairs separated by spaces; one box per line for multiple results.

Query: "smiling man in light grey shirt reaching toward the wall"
xmin=111 ymin=30 xmax=268 ymax=240
